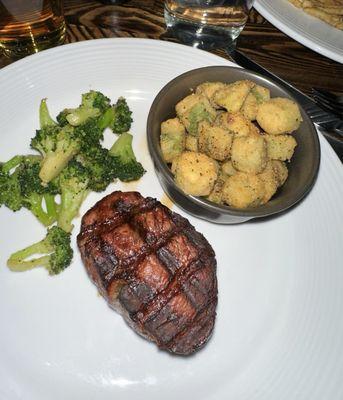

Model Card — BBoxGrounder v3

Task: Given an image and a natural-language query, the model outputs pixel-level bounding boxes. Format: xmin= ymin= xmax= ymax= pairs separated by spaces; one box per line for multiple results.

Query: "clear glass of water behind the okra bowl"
xmin=164 ymin=0 xmax=254 ymax=50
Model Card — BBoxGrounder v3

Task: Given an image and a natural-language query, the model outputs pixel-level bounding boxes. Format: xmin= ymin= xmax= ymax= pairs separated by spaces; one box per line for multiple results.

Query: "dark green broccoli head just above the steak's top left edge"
xmin=77 ymin=145 xmax=115 ymax=192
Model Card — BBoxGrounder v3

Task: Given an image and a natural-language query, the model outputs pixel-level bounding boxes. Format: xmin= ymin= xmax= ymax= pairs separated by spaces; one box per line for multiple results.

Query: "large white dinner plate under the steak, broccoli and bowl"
xmin=0 ymin=39 xmax=343 ymax=400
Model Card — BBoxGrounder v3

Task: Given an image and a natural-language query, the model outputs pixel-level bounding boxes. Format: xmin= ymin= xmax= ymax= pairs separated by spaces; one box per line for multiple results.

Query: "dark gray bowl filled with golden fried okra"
xmin=147 ymin=66 xmax=320 ymax=224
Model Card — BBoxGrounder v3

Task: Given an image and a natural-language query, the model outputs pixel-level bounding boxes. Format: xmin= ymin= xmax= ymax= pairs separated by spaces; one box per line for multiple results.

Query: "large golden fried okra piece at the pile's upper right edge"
xmin=256 ymin=97 xmax=302 ymax=135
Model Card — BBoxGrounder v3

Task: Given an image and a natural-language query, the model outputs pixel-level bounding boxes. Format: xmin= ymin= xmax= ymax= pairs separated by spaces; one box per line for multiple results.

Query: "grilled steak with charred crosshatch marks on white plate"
xmin=77 ymin=191 xmax=217 ymax=355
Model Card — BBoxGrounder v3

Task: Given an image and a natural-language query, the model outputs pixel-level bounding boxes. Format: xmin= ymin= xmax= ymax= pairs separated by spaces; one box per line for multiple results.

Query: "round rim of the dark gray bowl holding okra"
xmin=147 ymin=65 xmax=321 ymax=220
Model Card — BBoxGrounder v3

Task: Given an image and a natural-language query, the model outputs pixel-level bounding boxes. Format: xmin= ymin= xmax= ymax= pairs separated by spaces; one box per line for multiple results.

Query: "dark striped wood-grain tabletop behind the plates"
xmin=0 ymin=0 xmax=343 ymax=160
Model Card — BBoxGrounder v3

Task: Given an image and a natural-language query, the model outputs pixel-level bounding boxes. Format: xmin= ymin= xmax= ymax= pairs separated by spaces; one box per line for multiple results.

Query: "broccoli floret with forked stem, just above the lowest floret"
xmin=18 ymin=156 xmax=58 ymax=226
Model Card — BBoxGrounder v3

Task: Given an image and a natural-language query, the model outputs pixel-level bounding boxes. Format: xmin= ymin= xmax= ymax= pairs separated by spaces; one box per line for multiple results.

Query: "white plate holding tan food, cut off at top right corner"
xmin=254 ymin=0 xmax=343 ymax=63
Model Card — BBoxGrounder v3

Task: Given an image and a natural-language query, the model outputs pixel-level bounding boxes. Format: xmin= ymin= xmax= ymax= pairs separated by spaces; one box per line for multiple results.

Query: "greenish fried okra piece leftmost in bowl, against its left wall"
xmin=160 ymin=118 xmax=186 ymax=163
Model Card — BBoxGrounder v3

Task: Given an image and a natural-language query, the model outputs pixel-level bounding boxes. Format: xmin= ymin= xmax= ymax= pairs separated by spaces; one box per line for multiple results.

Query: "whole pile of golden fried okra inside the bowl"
xmin=161 ymin=80 xmax=301 ymax=208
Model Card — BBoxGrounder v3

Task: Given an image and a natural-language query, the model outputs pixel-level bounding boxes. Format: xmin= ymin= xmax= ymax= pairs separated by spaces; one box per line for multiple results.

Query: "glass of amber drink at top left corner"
xmin=0 ymin=0 xmax=66 ymax=57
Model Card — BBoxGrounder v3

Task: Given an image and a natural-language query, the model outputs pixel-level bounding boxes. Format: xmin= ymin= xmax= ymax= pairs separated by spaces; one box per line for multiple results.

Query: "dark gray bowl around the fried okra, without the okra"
xmin=147 ymin=66 xmax=320 ymax=224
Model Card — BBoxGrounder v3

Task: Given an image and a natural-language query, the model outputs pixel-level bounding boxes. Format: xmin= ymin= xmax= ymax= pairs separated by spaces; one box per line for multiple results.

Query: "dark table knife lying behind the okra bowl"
xmin=229 ymin=50 xmax=343 ymax=138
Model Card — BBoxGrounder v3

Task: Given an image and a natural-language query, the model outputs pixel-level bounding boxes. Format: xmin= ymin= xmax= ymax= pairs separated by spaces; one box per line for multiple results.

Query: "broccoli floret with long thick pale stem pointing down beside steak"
xmin=57 ymin=160 xmax=89 ymax=232
